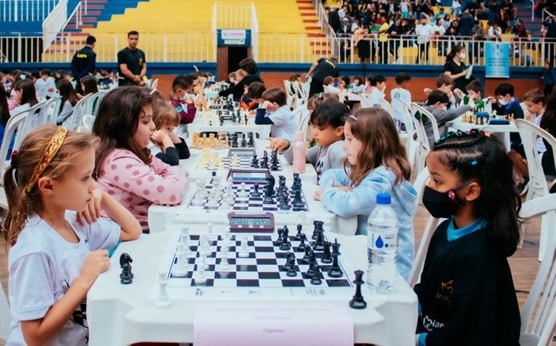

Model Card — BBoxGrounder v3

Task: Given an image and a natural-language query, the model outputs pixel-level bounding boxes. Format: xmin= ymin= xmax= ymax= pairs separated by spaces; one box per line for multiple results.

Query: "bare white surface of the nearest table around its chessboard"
xmin=87 ymin=225 xmax=417 ymax=346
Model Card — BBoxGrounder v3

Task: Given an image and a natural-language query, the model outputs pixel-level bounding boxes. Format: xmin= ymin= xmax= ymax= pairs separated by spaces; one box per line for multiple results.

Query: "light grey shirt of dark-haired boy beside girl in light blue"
xmin=283 ymin=141 xmax=346 ymax=179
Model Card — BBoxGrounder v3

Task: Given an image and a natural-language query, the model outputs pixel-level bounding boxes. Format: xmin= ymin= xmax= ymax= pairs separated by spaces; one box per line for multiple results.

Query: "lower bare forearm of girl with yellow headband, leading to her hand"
xmin=20 ymin=250 xmax=110 ymax=345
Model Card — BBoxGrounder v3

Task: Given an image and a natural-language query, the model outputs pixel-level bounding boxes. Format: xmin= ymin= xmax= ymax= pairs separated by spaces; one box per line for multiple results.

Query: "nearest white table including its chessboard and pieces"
xmin=87 ymin=223 xmax=417 ymax=346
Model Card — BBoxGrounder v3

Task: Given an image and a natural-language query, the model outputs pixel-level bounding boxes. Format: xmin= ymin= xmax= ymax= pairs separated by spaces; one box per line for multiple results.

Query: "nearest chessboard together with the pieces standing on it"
xmin=160 ymin=221 xmax=352 ymax=301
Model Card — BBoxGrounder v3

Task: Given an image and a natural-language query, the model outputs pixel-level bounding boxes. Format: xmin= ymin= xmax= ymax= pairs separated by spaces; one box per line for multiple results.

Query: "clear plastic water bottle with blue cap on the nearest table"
xmin=366 ymin=193 xmax=398 ymax=294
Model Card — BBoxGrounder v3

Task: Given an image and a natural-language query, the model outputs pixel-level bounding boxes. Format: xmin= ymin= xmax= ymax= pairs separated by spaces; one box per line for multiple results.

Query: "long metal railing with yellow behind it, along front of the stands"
xmin=0 ymin=32 xmax=556 ymax=67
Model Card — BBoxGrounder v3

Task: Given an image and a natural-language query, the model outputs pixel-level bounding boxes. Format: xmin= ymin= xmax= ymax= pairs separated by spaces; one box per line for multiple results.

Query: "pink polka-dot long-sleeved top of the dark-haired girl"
xmin=97 ymin=149 xmax=189 ymax=230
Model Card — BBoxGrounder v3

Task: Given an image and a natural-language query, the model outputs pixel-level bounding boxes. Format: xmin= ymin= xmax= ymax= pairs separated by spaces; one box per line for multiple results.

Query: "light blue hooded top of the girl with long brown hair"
xmin=320 ymin=166 xmax=417 ymax=280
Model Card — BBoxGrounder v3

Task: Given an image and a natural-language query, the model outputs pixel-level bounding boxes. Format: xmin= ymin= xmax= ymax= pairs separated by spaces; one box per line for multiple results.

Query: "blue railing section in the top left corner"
xmin=0 ymin=0 xmax=59 ymax=22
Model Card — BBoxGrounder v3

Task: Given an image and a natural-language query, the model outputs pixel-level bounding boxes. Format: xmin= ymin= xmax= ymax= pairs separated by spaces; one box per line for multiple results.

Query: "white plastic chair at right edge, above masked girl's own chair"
xmin=515 ymin=119 xmax=556 ymax=260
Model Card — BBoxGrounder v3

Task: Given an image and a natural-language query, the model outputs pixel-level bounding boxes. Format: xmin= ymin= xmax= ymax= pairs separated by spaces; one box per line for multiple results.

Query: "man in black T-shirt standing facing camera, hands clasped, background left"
xmin=118 ymin=30 xmax=147 ymax=86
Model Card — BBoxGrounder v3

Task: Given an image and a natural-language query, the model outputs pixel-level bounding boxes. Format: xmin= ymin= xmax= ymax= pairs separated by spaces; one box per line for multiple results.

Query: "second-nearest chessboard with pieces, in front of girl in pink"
xmin=187 ymin=184 xmax=309 ymax=213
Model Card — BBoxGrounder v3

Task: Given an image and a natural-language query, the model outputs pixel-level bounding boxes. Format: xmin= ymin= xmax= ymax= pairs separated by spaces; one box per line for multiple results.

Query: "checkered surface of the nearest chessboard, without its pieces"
xmin=163 ymin=233 xmax=353 ymax=295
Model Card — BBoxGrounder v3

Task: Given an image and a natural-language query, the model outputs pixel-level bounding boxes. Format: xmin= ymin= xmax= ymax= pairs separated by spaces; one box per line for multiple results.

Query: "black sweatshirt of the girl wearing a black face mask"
xmin=415 ymin=219 xmax=521 ymax=346
